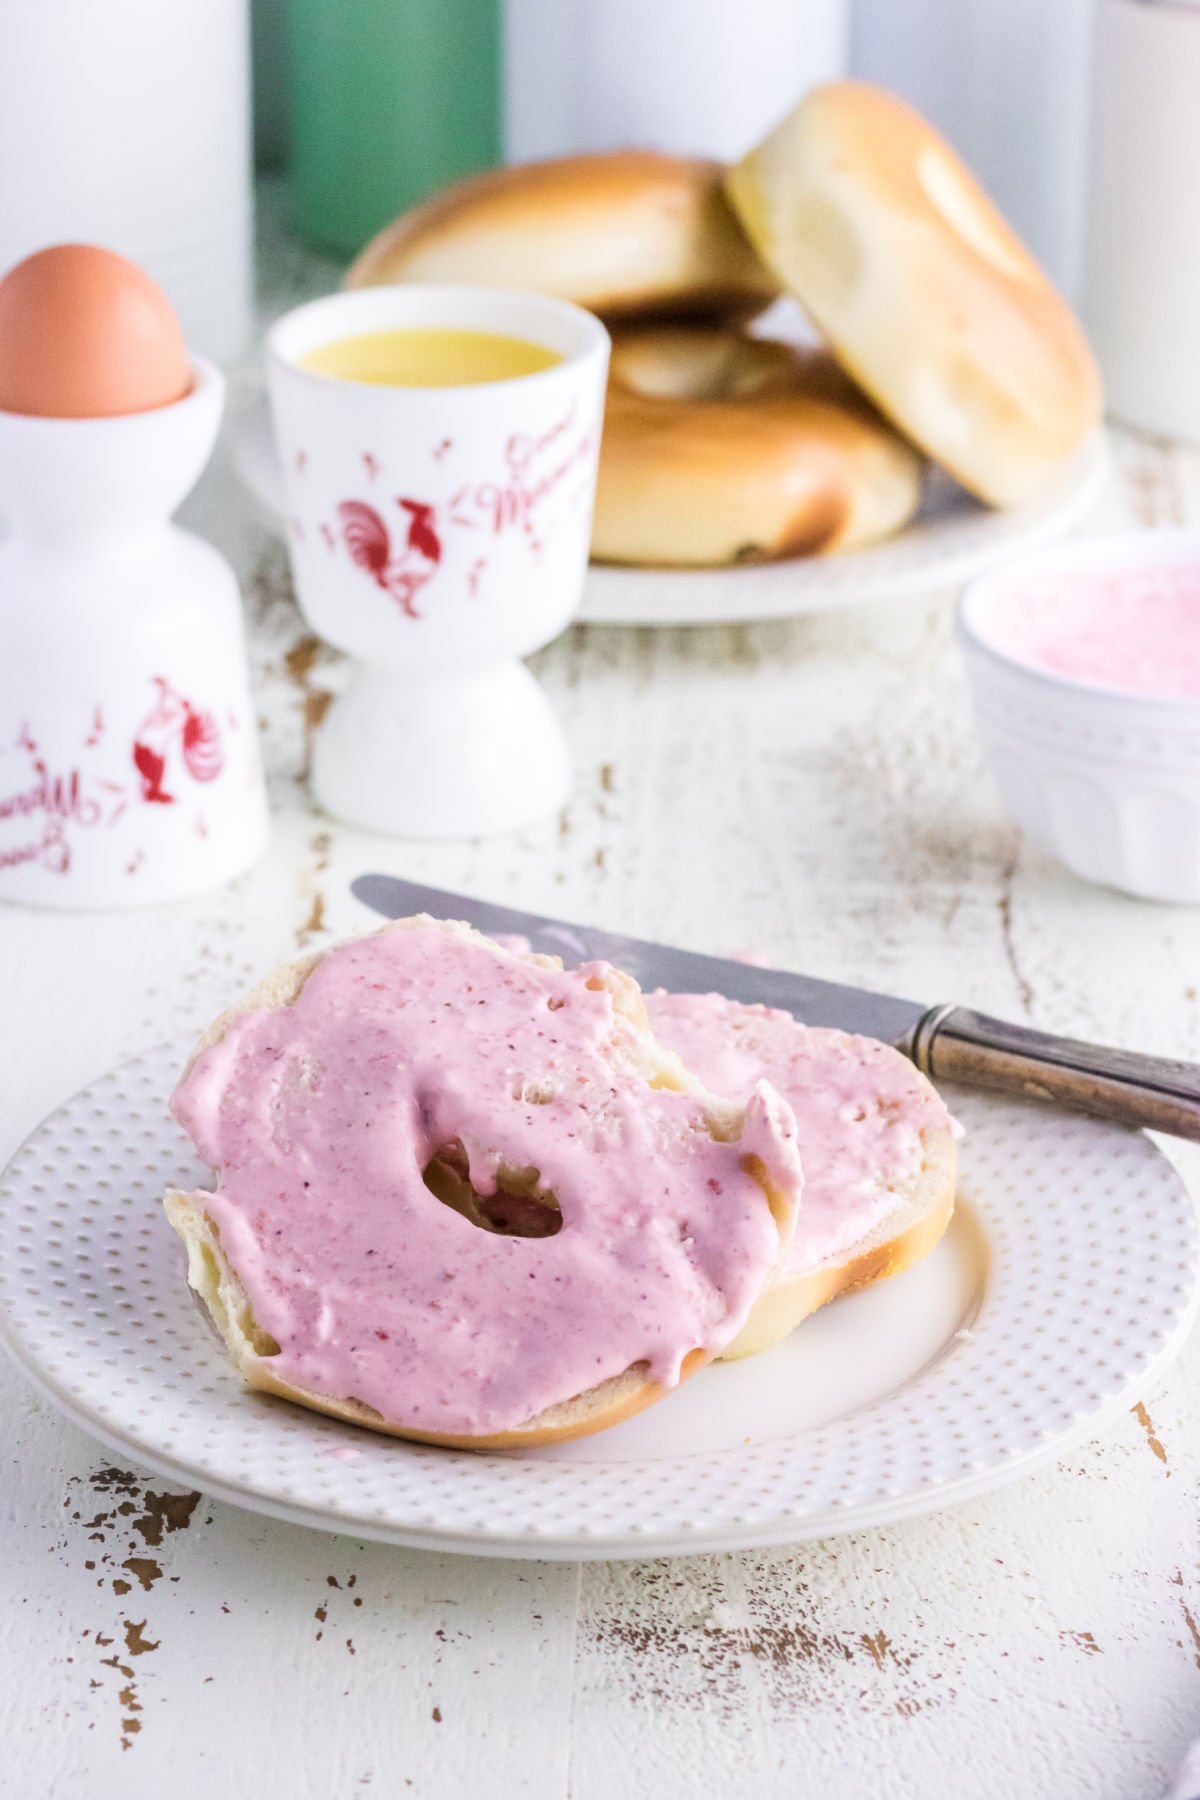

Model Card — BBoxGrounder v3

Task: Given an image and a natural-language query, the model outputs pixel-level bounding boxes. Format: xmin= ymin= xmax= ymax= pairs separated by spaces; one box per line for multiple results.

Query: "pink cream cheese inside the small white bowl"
xmin=975 ymin=551 xmax=1200 ymax=698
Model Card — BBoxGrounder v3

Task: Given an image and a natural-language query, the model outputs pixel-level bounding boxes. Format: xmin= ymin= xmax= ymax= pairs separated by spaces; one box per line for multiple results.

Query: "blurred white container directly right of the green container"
xmin=504 ymin=0 xmax=849 ymax=162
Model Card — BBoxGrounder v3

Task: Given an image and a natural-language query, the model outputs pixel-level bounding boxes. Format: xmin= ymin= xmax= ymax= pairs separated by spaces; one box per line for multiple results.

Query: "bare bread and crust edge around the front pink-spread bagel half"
xmin=164 ymin=916 xmax=792 ymax=1451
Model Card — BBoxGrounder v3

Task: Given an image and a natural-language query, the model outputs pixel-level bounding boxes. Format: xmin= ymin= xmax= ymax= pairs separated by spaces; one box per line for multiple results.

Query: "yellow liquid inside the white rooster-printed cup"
xmin=299 ymin=331 xmax=563 ymax=387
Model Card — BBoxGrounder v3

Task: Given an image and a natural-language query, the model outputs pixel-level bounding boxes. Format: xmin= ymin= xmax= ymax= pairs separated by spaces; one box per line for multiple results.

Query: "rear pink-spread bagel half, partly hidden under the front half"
xmin=646 ymin=992 xmax=957 ymax=1357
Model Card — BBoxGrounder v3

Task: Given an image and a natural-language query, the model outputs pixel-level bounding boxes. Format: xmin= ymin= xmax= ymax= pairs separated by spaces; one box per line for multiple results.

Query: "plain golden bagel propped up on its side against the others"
xmin=727 ymin=81 xmax=1101 ymax=506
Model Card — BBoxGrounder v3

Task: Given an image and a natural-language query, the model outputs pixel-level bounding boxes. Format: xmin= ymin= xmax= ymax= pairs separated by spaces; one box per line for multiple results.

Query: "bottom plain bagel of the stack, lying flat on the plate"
xmin=592 ymin=326 xmax=921 ymax=567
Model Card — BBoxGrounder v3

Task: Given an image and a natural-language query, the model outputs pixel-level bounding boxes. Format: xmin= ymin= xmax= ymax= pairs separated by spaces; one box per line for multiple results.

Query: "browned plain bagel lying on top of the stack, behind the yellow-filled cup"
xmin=345 ymin=149 xmax=779 ymax=319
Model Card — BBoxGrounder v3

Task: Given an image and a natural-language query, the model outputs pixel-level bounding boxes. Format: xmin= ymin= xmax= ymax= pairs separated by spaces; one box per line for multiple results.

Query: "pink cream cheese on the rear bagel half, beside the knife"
xmin=646 ymin=992 xmax=950 ymax=1274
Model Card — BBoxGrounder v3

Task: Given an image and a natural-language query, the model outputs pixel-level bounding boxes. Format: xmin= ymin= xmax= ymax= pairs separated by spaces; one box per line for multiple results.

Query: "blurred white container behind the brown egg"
xmin=0 ymin=0 xmax=252 ymax=362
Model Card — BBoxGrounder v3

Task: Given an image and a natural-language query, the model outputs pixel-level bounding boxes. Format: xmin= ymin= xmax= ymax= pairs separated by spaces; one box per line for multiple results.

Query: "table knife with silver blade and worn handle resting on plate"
xmin=351 ymin=875 xmax=1200 ymax=1141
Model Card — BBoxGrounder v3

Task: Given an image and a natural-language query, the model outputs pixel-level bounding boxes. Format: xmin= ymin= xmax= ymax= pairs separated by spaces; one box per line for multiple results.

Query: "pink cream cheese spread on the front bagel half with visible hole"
xmin=173 ymin=922 xmax=801 ymax=1436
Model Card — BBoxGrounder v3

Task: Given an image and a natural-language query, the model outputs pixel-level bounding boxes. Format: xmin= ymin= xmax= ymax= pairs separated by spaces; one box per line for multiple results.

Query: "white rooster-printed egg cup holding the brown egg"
xmin=0 ymin=356 xmax=266 ymax=907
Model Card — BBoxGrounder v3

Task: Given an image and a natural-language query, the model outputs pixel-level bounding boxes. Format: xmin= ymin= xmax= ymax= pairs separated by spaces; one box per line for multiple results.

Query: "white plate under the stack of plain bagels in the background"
xmin=234 ymin=383 xmax=1108 ymax=625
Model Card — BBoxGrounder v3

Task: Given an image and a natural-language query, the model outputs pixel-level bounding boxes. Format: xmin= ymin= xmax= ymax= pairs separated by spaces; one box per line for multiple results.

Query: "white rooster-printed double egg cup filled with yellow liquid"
xmin=266 ymin=286 xmax=608 ymax=839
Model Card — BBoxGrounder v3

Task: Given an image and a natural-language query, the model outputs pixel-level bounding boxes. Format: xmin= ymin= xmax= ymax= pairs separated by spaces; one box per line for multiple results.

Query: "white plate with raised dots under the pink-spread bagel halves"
xmin=0 ymin=1051 xmax=1198 ymax=1557
